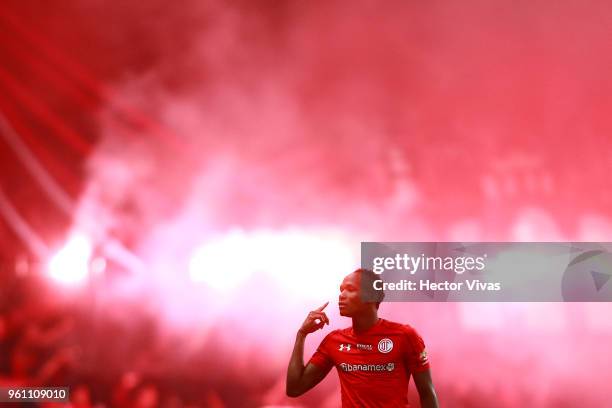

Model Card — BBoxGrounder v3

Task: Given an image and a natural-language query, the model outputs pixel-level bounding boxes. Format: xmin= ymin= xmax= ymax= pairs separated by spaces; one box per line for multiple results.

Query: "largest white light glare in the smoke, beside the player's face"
xmin=189 ymin=230 xmax=359 ymax=298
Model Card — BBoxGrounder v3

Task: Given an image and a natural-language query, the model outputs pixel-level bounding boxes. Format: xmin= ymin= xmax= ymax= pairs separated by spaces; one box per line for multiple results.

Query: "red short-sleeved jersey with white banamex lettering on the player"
xmin=310 ymin=319 xmax=429 ymax=408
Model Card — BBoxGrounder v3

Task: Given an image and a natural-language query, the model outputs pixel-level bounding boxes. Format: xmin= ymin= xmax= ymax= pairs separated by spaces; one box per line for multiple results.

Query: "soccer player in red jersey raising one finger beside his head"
xmin=287 ymin=269 xmax=438 ymax=408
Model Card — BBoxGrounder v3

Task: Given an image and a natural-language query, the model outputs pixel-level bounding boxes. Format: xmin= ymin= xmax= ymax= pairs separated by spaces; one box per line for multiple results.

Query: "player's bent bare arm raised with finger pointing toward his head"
xmin=287 ymin=302 xmax=331 ymax=397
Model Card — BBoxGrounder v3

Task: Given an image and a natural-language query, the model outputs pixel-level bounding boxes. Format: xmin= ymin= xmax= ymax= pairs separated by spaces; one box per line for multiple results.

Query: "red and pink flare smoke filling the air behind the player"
xmin=0 ymin=0 xmax=612 ymax=407
